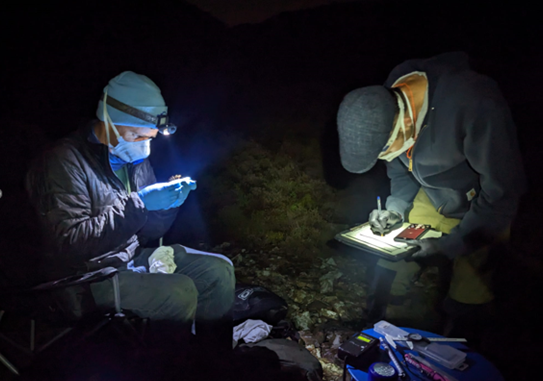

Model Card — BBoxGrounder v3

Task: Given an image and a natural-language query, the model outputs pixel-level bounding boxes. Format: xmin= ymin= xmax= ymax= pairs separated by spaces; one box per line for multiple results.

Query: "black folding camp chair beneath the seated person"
xmin=0 ymin=267 xmax=148 ymax=375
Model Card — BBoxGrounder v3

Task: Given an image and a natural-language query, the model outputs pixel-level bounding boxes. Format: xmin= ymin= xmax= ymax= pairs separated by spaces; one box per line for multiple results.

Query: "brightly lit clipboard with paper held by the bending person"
xmin=335 ymin=222 xmax=442 ymax=262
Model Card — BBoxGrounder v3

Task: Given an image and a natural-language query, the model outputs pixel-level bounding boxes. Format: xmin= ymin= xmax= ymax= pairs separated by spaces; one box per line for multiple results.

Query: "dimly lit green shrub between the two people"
xmin=200 ymin=141 xmax=335 ymax=254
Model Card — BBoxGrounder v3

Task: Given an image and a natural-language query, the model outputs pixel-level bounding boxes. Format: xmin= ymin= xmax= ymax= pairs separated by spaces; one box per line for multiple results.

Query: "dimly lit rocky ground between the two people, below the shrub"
xmin=205 ymin=238 xmax=446 ymax=381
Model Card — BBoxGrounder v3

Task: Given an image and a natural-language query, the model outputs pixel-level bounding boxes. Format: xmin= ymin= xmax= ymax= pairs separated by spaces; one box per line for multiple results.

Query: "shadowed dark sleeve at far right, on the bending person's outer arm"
xmin=440 ymin=79 xmax=526 ymax=258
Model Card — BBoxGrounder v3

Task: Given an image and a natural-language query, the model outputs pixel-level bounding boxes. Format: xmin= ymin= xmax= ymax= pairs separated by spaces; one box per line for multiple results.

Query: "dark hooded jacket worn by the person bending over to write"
xmin=385 ymin=52 xmax=525 ymax=258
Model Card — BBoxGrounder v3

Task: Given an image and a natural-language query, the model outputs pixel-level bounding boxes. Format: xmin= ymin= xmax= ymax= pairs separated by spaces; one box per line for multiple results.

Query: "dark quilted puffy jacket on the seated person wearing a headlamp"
xmin=26 ymin=123 xmax=177 ymax=279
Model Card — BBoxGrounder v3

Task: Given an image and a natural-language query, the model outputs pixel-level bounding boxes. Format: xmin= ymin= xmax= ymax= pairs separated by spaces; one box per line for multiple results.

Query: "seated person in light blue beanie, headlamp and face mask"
xmin=27 ymin=71 xmax=235 ymax=372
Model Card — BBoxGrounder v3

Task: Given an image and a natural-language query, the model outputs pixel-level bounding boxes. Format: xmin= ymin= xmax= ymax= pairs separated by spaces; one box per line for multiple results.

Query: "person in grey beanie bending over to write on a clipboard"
xmin=337 ymin=52 xmax=525 ymax=340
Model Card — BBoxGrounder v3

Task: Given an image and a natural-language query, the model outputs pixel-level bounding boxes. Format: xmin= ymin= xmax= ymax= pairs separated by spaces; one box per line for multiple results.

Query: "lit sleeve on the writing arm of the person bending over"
xmin=386 ymin=158 xmax=420 ymax=220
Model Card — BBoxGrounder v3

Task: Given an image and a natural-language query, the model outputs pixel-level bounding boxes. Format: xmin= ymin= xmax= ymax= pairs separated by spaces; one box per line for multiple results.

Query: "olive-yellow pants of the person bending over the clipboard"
xmin=376 ymin=188 xmax=500 ymax=304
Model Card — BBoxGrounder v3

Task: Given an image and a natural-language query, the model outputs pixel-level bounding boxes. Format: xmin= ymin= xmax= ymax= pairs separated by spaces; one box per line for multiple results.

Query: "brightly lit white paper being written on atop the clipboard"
xmin=342 ymin=222 xmax=442 ymax=255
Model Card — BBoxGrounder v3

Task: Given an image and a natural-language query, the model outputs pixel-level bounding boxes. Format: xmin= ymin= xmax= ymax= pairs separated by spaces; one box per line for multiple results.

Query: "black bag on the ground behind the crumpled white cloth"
xmin=234 ymin=283 xmax=288 ymax=325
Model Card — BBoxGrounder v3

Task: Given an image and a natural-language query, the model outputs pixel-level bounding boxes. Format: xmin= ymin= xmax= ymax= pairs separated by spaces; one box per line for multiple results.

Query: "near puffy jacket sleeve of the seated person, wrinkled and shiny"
xmin=26 ymin=148 xmax=148 ymax=263
